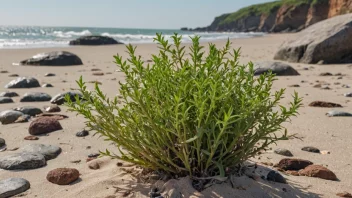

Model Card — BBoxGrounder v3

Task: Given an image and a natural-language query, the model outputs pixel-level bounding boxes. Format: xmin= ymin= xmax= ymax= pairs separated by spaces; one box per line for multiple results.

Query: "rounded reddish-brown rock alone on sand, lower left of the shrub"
xmin=46 ymin=168 xmax=79 ymax=185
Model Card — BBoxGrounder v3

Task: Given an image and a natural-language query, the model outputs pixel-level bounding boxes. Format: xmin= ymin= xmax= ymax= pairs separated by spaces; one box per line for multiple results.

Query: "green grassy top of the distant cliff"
xmin=213 ymin=0 xmax=328 ymax=25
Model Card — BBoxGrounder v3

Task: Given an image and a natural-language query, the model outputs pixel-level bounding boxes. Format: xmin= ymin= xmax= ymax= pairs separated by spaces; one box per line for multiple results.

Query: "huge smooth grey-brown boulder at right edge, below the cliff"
xmin=274 ymin=14 xmax=352 ymax=64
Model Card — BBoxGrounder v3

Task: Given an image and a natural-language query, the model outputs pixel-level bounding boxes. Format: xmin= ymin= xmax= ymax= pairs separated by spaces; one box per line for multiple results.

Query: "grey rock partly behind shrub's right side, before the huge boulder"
xmin=254 ymin=61 xmax=300 ymax=76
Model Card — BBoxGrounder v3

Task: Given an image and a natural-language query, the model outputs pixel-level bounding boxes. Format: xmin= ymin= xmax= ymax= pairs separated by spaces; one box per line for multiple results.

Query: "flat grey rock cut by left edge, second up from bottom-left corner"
xmin=0 ymin=153 xmax=46 ymax=170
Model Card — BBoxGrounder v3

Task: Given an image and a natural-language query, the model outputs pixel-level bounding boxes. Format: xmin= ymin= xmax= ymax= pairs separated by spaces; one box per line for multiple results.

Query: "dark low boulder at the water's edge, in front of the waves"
xmin=70 ymin=36 xmax=123 ymax=45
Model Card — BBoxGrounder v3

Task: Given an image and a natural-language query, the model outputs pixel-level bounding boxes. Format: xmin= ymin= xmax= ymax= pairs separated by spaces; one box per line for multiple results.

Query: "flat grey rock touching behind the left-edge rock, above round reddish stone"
xmin=21 ymin=144 xmax=61 ymax=160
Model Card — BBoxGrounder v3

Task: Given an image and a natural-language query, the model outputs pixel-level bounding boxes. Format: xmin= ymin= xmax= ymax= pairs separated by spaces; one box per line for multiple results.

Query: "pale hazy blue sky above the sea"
xmin=0 ymin=0 xmax=268 ymax=29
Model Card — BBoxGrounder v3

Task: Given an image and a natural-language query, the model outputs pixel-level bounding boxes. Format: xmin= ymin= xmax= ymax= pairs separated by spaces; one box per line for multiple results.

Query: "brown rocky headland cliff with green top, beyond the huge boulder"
xmin=191 ymin=0 xmax=352 ymax=32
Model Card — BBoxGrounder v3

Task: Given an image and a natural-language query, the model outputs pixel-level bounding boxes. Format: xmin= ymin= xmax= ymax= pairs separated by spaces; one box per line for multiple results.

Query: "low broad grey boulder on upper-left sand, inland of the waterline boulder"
xmin=21 ymin=51 xmax=83 ymax=66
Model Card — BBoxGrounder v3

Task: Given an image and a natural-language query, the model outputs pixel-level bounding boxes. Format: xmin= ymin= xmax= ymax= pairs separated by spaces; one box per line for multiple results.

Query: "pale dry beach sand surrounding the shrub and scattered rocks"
xmin=0 ymin=34 xmax=352 ymax=198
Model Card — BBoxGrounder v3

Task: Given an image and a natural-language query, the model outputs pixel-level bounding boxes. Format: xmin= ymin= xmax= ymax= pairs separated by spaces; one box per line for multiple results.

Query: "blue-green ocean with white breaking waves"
xmin=0 ymin=26 xmax=264 ymax=48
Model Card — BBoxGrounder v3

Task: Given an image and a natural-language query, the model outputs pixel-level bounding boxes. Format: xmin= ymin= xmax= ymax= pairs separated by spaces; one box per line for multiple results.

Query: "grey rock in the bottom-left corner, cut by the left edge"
xmin=0 ymin=178 xmax=30 ymax=198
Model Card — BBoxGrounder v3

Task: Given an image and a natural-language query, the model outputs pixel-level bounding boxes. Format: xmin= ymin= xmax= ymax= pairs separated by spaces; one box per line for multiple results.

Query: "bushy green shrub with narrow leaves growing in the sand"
xmin=66 ymin=34 xmax=301 ymax=181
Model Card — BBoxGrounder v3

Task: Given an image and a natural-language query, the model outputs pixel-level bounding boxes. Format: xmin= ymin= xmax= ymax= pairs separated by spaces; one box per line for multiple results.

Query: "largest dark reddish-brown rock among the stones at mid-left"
xmin=28 ymin=117 xmax=62 ymax=135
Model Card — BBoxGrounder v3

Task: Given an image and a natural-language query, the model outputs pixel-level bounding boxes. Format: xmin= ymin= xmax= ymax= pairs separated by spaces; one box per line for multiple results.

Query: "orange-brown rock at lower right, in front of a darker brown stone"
xmin=299 ymin=165 xmax=337 ymax=181
